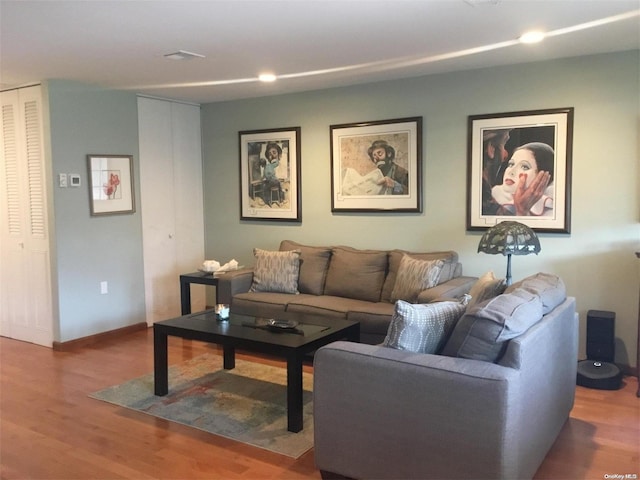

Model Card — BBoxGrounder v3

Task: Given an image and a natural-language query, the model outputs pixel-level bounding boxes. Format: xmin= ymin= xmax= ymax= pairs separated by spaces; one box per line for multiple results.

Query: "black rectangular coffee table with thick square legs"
xmin=153 ymin=310 xmax=360 ymax=432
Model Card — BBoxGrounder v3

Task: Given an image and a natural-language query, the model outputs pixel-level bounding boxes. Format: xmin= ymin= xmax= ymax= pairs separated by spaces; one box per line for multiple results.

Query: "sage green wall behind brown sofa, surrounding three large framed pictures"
xmin=202 ymin=51 xmax=640 ymax=365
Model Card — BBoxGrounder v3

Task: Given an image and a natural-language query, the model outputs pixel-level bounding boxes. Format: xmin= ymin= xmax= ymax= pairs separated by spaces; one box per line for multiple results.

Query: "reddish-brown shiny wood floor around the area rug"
xmin=0 ymin=329 xmax=640 ymax=480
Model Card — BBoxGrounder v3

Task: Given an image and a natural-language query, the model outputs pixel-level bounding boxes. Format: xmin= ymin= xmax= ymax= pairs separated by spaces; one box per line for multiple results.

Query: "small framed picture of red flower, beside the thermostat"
xmin=87 ymin=155 xmax=136 ymax=216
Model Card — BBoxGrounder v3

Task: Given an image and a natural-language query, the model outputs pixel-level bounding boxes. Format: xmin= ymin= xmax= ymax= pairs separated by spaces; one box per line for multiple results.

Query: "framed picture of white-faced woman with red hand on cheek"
xmin=467 ymin=108 xmax=573 ymax=233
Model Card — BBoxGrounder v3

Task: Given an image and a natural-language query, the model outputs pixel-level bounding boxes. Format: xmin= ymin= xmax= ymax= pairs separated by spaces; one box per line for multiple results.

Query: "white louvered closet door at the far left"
xmin=0 ymin=86 xmax=53 ymax=347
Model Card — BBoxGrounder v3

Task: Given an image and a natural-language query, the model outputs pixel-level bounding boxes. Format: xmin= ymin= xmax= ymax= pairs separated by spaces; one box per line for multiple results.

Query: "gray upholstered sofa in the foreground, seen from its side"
xmin=313 ymin=274 xmax=578 ymax=480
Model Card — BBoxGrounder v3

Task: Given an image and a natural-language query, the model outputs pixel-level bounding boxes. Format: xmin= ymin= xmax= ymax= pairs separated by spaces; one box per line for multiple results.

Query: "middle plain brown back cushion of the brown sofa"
xmin=324 ymin=247 xmax=387 ymax=302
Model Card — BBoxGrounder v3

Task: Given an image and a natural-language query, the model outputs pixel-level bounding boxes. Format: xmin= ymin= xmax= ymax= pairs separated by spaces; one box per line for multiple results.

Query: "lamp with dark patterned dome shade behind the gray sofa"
xmin=478 ymin=221 xmax=540 ymax=285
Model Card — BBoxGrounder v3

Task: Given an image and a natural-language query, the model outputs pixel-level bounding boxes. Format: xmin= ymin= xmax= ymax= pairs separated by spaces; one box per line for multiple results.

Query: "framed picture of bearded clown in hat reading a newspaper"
xmin=330 ymin=117 xmax=422 ymax=212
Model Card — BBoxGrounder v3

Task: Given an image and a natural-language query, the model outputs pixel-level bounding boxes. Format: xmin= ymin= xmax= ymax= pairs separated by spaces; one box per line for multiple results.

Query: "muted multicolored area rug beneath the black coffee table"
xmin=89 ymin=353 xmax=313 ymax=458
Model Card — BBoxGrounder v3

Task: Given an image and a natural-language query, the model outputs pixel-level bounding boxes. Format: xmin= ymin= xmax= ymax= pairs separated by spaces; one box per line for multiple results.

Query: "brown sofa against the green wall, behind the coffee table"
xmin=218 ymin=240 xmax=477 ymax=344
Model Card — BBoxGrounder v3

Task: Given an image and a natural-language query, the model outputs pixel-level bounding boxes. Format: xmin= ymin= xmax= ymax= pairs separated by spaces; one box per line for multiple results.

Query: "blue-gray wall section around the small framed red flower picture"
xmin=45 ymin=80 xmax=145 ymax=342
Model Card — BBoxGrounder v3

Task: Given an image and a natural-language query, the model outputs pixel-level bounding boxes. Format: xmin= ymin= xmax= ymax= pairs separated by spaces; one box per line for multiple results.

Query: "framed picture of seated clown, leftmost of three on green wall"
xmin=238 ymin=127 xmax=302 ymax=222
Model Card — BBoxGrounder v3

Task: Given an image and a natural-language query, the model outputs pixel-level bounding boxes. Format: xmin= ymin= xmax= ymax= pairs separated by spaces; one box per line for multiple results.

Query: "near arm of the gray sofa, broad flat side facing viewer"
xmin=313 ymin=342 xmax=522 ymax=479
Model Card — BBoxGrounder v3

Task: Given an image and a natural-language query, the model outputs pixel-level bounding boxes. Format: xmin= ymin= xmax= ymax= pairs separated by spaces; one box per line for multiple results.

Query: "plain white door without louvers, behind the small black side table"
xmin=138 ymin=97 xmax=205 ymax=325
